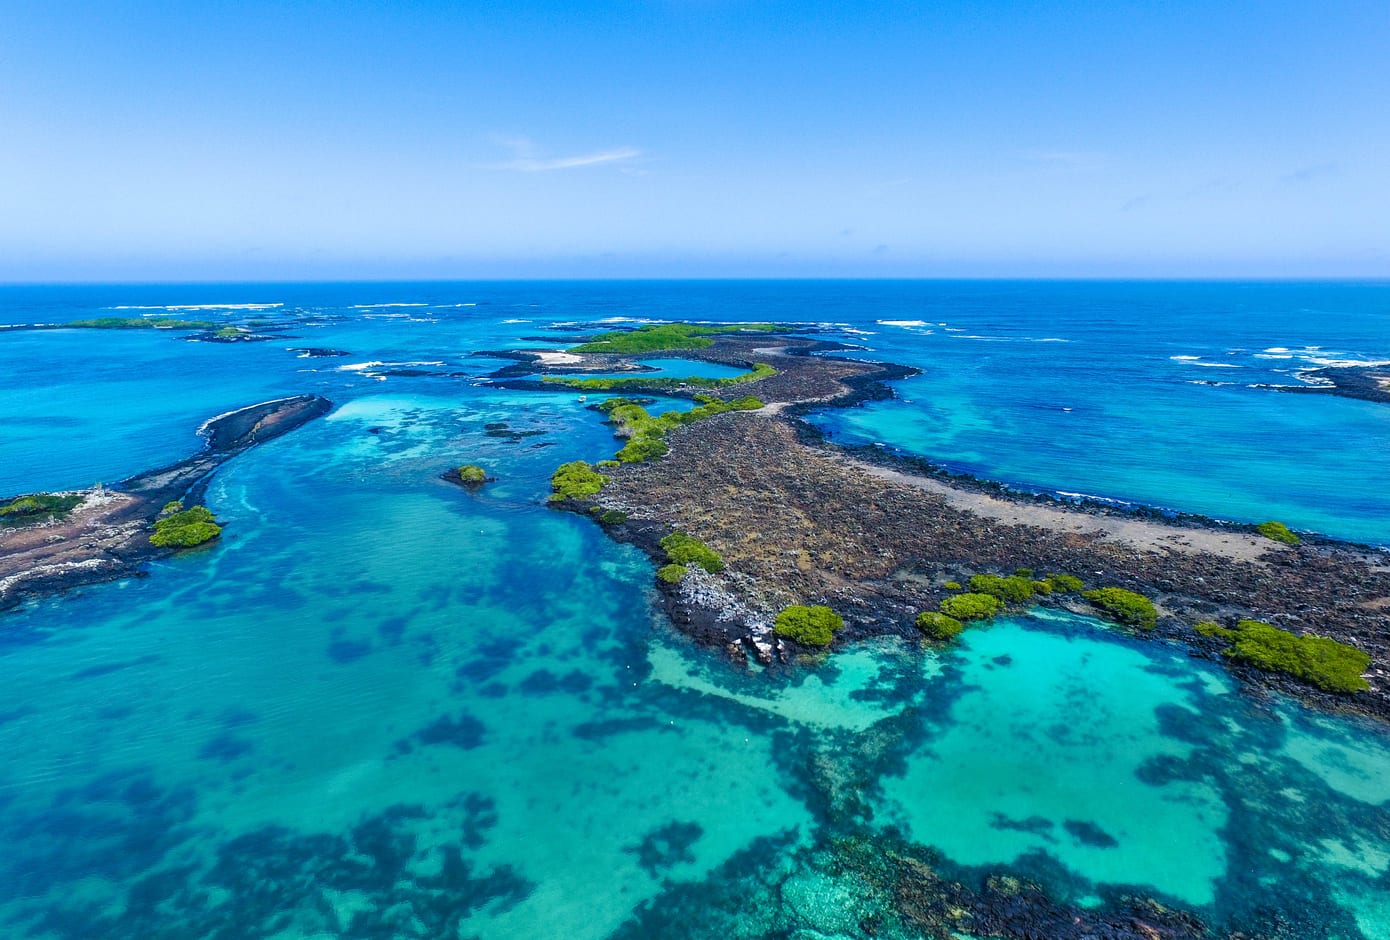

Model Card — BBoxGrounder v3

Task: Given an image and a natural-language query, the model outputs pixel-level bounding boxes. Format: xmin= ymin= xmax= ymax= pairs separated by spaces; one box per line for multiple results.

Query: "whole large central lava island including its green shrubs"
xmin=525 ymin=324 xmax=1390 ymax=720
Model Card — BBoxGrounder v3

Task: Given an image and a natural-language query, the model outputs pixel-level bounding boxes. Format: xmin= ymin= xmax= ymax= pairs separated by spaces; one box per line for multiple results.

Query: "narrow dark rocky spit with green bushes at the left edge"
xmin=0 ymin=395 xmax=332 ymax=610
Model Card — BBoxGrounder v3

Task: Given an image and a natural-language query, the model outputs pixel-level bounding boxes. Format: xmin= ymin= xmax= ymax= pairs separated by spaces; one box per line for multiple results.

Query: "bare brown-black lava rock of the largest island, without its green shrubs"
xmin=528 ymin=335 xmax=1390 ymax=720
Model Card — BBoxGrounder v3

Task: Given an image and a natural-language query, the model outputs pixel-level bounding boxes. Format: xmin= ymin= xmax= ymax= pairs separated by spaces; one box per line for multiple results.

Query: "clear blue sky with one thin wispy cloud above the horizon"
xmin=0 ymin=0 xmax=1390 ymax=282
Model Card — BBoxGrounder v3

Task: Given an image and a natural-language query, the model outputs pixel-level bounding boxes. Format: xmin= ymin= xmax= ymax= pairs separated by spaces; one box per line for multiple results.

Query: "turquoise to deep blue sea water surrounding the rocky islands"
xmin=0 ymin=282 xmax=1390 ymax=940
